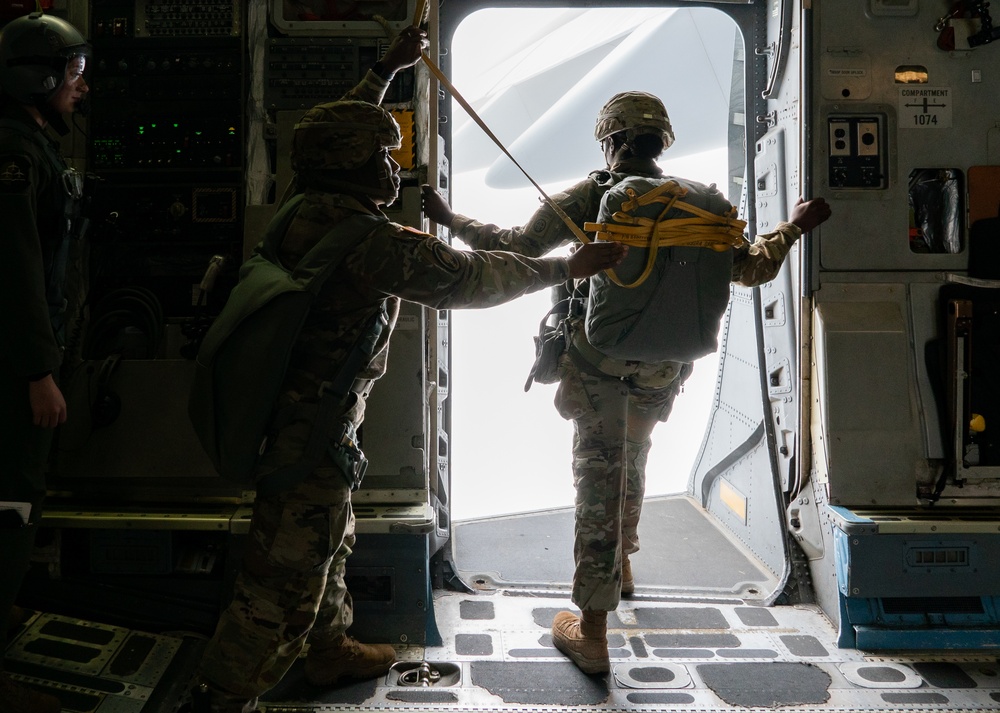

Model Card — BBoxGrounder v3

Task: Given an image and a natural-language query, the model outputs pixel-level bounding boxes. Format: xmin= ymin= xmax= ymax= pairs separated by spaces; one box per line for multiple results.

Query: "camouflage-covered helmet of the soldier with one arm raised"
xmin=292 ymin=101 xmax=403 ymax=173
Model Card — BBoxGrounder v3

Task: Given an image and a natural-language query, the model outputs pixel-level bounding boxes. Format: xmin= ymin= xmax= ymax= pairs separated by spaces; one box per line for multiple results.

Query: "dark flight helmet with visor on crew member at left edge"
xmin=0 ymin=12 xmax=91 ymax=109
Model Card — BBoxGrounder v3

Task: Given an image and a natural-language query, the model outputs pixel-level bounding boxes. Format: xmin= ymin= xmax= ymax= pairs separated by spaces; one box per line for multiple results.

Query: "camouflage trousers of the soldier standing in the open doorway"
xmin=555 ymin=322 xmax=691 ymax=611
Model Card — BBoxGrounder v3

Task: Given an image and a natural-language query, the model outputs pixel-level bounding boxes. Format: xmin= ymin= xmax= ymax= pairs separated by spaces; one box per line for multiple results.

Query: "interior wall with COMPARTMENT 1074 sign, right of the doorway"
xmin=792 ymin=0 xmax=1000 ymax=649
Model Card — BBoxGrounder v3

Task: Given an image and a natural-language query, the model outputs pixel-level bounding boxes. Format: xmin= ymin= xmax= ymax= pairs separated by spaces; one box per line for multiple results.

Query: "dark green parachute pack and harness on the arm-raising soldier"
xmin=188 ymin=194 xmax=388 ymax=493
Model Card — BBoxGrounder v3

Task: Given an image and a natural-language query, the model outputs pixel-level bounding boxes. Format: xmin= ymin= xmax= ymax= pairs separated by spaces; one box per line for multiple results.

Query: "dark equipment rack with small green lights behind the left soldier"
xmin=87 ymin=0 xmax=247 ymax=323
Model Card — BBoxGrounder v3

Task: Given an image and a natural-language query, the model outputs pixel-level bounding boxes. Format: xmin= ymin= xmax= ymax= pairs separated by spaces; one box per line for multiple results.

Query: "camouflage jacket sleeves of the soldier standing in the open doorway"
xmin=449 ymin=159 xmax=802 ymax=287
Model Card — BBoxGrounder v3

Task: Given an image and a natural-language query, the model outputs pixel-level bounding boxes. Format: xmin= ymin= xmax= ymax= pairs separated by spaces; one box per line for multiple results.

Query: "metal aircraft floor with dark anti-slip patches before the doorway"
xmin=6 ymin=591 xmax=1000 ymax=713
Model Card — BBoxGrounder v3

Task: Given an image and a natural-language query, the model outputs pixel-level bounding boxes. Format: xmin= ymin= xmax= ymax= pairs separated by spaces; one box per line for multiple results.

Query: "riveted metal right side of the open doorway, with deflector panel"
xmin=689 ymin=2 xmax=804 ymax=602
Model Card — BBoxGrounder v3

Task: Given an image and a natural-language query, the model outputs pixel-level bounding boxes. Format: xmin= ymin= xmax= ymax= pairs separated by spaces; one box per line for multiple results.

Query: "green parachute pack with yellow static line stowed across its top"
xmin=584 ymin=176 xmax=746 ymax=362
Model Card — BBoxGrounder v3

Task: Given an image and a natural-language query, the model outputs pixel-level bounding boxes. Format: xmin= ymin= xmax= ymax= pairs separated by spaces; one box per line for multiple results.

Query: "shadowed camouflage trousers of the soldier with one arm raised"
xmin=199 ymin=432 xmax=355 ymax=700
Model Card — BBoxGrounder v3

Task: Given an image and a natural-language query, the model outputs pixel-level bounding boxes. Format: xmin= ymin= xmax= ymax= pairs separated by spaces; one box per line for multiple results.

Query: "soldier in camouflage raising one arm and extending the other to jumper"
xmin=192 ymin=28 xmax=625 ymax=713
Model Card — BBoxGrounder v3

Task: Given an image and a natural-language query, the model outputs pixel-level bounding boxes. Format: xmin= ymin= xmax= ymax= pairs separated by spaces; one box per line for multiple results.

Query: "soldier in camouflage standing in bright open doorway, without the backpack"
xmin=423 ymin=92 xmax=830 ymax=673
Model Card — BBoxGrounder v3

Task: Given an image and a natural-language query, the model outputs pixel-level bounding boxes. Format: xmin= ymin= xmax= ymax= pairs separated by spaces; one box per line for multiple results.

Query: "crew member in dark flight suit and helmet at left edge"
xmin=0 ymin=13 xmax=90 ymax=713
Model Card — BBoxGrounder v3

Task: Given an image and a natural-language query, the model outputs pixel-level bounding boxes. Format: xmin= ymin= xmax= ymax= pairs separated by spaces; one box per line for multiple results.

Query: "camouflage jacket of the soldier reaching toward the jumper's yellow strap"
xmin=280 ymin=191 xmax=569 ymax=420
